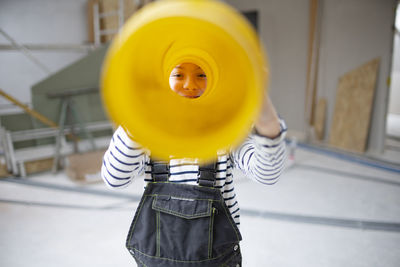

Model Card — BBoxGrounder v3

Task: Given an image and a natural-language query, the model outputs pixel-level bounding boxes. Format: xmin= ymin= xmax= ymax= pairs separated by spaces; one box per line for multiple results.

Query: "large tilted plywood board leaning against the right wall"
xmin=329 ymin=59 xmax=379 ymax=153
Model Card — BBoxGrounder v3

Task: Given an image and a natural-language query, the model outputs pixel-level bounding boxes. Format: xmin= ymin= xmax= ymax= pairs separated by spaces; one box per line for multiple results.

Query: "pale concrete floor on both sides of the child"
xmin=0 ymin=148 xmax=400 ymax=267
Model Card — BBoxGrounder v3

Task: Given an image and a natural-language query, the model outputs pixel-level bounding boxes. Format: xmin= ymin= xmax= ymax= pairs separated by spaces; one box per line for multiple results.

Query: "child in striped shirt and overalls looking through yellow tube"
xmin=102 ymin=63 xmax=286 ymax=267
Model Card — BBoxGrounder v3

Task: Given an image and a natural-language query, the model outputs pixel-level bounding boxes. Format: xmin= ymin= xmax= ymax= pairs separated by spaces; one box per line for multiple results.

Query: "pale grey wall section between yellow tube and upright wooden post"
xmin=225 ymin=0 xmax=309 ymax=135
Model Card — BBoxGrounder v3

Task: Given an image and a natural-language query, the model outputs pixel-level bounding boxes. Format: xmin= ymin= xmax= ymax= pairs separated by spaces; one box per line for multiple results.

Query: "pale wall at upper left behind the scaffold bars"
xmin=0 ymin=0 xmax=87 ymax=114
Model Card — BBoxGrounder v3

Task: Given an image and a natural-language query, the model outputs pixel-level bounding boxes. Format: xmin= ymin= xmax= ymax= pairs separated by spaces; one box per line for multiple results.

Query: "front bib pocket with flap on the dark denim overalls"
xmin=152 ymin=196 xmax=213 ymax=261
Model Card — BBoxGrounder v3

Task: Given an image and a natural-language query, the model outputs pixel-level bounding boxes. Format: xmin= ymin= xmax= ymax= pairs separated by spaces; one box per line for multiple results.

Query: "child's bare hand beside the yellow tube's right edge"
xmin=255 ymin=95 xmax=281 ymax=139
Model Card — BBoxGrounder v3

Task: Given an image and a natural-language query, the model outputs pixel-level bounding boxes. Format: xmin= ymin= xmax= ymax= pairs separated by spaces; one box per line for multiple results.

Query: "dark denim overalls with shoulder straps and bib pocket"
xmin=126 ymin=161 xmax=242 ymax=267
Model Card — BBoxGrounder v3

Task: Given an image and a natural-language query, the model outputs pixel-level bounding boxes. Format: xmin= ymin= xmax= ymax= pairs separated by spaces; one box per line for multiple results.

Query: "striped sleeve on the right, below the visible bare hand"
xmin=232 ymin=120 xmax=287 ymax=185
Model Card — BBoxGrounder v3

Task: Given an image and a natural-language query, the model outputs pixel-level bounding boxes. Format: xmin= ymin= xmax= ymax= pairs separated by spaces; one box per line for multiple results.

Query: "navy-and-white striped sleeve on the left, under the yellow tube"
xmin=101 ymin=126 xmax=146 ymax=188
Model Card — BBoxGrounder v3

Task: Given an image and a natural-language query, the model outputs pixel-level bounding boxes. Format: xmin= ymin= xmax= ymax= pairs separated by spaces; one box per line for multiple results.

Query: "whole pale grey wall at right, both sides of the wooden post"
xmin=226 ymin=0 xmax=396 ymax=152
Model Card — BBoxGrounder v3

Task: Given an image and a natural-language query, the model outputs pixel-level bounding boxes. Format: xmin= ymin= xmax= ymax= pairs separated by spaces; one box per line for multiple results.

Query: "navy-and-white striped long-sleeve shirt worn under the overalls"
xmin=101 ymin=120 xmax=286 ymax=225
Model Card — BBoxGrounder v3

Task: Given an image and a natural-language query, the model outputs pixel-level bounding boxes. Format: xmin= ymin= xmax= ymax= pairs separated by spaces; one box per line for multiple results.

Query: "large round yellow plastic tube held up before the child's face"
xmin=102 ymin=0 xmax=268 ymax=161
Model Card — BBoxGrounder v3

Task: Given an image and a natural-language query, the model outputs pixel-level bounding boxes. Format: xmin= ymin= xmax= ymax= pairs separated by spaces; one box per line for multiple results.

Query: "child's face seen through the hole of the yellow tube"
xmin=169 ymin=63 xmax=207 ymax=98
